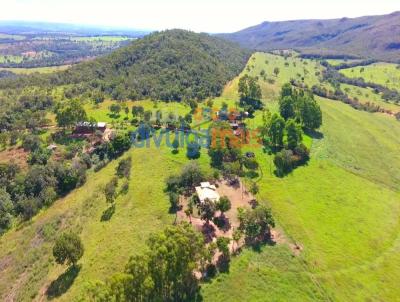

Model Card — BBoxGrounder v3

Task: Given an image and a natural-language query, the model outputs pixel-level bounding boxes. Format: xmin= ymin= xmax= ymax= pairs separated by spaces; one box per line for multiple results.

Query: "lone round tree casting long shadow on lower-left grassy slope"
xmin=53 ymin=233 xmax=84 ymax=266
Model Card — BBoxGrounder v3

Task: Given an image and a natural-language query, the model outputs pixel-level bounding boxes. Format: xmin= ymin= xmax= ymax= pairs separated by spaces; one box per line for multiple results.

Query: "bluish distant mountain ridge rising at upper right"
xmin=218 ymin=11 xmax=400 ymax=62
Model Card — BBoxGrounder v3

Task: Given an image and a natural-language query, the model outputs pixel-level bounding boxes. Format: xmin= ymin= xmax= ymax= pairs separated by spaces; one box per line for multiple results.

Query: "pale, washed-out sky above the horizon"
xmin=0 ymin=0 xmax=400 ymax=32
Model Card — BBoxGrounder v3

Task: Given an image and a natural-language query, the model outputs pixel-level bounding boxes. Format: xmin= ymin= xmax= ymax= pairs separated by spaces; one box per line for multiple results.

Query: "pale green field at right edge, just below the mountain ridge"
xmin=340 ymin=63 xmax=400 ymax=90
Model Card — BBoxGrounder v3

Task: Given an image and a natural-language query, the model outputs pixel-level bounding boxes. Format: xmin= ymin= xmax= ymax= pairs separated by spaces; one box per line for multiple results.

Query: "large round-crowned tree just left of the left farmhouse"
xmin=56 ymin=99 xmax=87 ymax=128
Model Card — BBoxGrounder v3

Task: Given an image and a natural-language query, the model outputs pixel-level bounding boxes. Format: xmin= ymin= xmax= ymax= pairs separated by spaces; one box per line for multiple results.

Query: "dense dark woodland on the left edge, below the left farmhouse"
xmin=0 ymin=130 xmax=131 ymax=234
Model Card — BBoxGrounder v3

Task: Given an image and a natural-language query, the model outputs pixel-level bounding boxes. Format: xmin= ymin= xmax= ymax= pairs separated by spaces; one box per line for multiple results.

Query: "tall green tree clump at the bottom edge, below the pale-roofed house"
xmin=87 ymin=224 xmax=209 ymax=302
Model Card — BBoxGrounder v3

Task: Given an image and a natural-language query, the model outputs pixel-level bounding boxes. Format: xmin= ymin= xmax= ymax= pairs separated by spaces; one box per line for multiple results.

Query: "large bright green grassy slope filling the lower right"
xmin=203 ymin=54 xmax=400 ymax=301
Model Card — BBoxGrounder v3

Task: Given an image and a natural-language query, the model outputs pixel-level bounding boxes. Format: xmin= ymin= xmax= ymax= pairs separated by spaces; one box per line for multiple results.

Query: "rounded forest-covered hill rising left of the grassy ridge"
xmin=0 ymin=30 xmax=249 ymax=101
